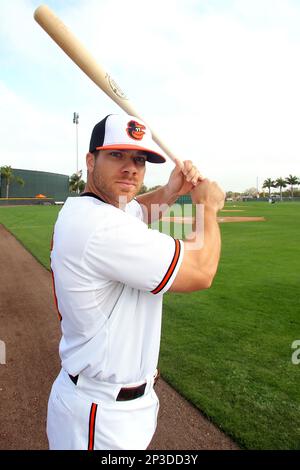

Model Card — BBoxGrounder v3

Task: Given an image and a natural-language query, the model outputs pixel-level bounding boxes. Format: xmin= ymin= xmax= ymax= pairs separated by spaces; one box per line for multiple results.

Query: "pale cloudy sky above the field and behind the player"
xmin=0 ymin=0 xmax=300 ymax=191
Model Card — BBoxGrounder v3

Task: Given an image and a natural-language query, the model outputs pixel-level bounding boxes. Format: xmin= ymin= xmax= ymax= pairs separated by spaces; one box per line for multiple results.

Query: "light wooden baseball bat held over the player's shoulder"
xmin=34 ymin=5 xmax=183 ymax=167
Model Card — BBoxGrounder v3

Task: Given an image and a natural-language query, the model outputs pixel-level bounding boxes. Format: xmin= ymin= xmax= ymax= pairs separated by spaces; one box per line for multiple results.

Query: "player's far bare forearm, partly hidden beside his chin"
xmin=136 ymin=185 xmax=178 ymax=223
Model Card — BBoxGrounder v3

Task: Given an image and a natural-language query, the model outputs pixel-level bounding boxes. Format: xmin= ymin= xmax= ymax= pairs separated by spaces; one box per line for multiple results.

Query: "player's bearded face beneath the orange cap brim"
xmin=88 ymin=150 xmax=146 ymax=206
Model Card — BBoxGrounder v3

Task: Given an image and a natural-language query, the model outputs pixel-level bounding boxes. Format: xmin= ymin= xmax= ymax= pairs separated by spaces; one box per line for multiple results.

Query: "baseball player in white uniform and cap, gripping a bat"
xmin=47 ymin=114 xmax=224 ymax=450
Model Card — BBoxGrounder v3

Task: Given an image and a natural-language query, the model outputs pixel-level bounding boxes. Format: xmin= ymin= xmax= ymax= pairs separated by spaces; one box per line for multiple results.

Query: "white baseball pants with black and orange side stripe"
xmin=47 ymin=369 xmax=159 ymax=450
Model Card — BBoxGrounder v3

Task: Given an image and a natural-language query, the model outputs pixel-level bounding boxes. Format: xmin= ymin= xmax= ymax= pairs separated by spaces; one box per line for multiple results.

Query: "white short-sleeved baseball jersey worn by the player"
xmin=51 ymin=196 xmax=183 ymax=384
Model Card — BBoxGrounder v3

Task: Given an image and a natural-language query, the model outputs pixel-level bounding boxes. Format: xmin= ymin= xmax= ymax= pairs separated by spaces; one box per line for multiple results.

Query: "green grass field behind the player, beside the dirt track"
xmin=0 ymin=202 xmax=300 ymax=449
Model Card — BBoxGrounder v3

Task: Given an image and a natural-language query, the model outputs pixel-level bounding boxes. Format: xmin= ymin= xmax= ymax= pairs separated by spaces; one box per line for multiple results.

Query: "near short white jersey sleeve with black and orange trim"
xmin=84 ymin=209 xmax=184 ymax=294
